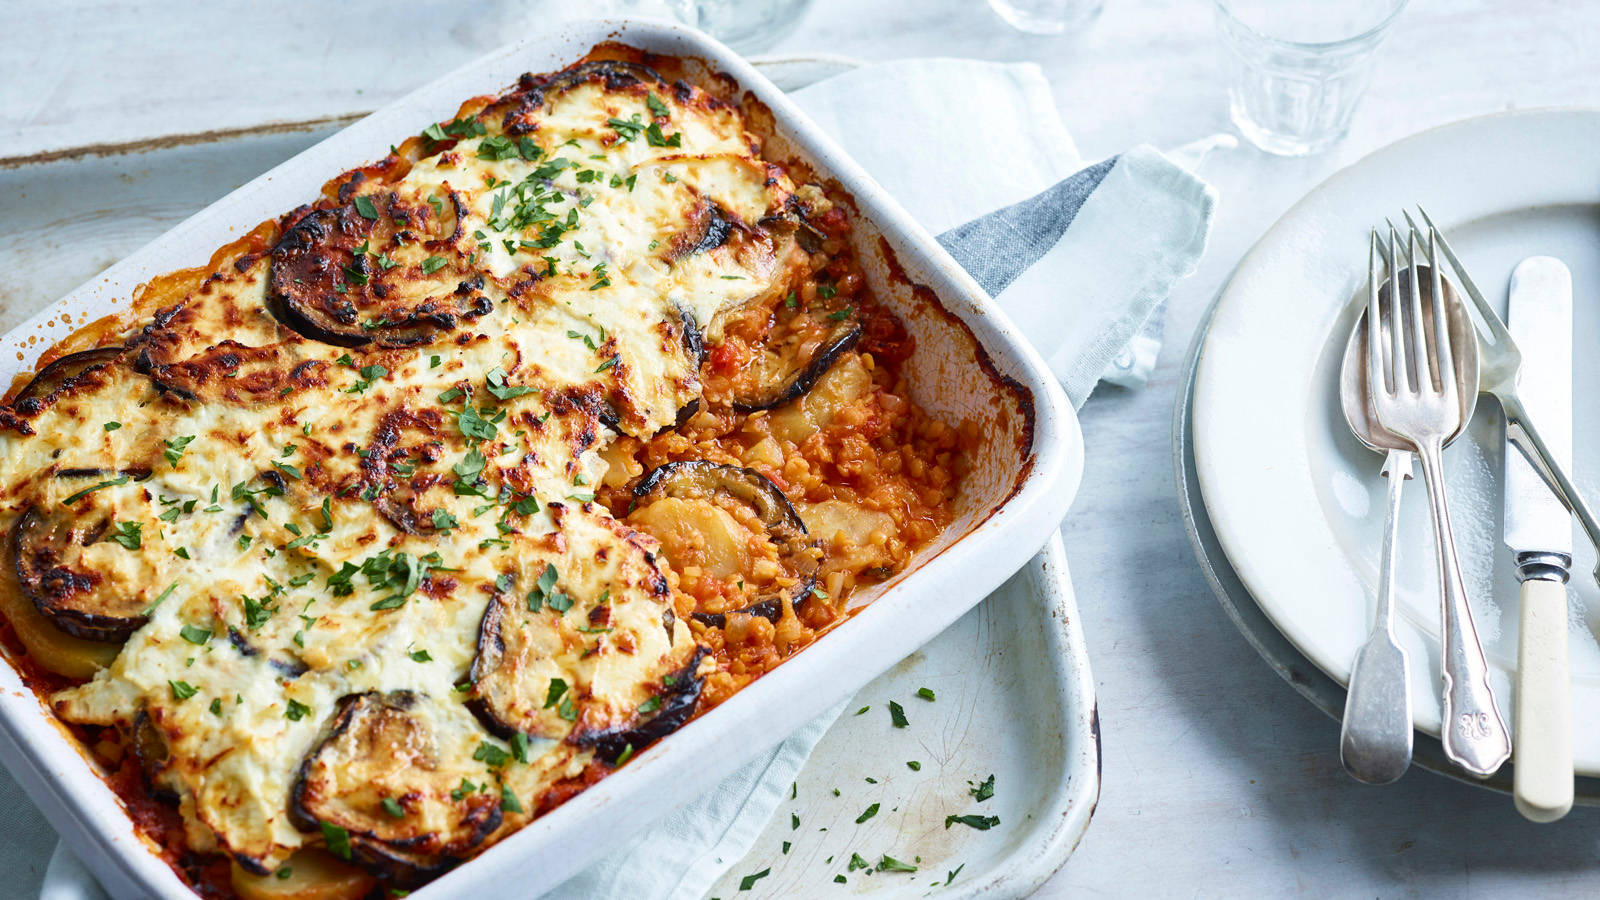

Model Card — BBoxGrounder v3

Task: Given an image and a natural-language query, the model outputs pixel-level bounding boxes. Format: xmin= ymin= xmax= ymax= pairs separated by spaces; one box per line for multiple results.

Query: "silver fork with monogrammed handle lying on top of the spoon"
xmin=1366 ymin=226 xmax=1510 ymax=777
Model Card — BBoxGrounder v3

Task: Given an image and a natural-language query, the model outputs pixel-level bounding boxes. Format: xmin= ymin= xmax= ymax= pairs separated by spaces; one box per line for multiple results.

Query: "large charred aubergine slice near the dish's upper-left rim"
xmin=266 ymin=191 xmax=493 ymax=348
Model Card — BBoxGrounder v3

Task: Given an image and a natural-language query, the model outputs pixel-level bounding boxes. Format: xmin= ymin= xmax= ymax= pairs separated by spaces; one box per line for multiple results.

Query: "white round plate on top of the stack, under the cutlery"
xmin=1194 ymin=110 xmax=1600 ymax=775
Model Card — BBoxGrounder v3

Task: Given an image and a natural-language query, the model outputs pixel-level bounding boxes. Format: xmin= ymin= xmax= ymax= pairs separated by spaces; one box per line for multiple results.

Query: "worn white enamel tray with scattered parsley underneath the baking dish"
xmin=18 ymin=54 xmax=1099 ymax=900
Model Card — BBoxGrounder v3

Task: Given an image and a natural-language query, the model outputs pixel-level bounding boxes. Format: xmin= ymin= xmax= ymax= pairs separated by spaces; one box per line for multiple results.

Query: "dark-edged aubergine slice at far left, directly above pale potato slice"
xmin=11 ymin=506 xmax=149 ymax=644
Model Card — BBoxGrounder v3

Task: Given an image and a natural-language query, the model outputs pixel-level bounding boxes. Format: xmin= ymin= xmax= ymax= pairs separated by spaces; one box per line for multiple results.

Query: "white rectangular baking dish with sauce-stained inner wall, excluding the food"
xmin=0 ymin=19 xmax=1083 ymax=900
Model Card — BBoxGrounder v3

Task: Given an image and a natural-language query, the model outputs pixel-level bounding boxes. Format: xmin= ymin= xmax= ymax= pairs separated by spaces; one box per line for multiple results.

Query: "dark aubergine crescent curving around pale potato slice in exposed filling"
xmin=634 ymin=460 xmax=818 ymax=628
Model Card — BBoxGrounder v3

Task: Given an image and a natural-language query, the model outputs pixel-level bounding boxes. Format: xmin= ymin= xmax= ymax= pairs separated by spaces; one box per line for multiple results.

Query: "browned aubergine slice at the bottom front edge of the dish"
xmin=290 ymin=690 xmax=501 ymax=887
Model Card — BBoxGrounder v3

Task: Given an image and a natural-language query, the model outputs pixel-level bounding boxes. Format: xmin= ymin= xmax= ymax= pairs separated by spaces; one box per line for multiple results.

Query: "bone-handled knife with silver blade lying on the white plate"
xmin=1506 ymin=256 xmax=1573 ymax=822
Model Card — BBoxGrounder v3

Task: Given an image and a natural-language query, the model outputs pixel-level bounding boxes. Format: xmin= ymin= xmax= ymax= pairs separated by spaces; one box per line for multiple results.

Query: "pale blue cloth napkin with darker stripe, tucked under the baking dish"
xmin=37 ymin=59 xmax=1216 ymax=900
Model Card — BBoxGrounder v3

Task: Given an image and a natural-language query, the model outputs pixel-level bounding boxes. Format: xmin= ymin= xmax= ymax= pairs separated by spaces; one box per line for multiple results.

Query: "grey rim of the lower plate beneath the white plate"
xmin=1173 ymin=282 xmax=1600 ymax=806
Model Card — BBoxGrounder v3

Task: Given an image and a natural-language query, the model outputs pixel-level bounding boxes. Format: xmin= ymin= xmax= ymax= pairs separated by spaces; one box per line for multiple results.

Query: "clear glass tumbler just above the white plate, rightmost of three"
xmin=1214 ymin=0 xmax=1406 ymax=157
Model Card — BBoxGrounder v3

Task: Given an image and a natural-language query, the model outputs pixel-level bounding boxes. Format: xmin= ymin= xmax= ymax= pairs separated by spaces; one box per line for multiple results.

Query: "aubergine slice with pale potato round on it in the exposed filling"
xmin=627 ymin=460 xmax=821 ymax=626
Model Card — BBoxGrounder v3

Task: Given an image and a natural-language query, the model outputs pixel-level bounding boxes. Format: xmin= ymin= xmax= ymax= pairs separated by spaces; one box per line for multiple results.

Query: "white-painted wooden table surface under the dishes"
xmin=9 ymin=0 xmax=1600 ymax=897
